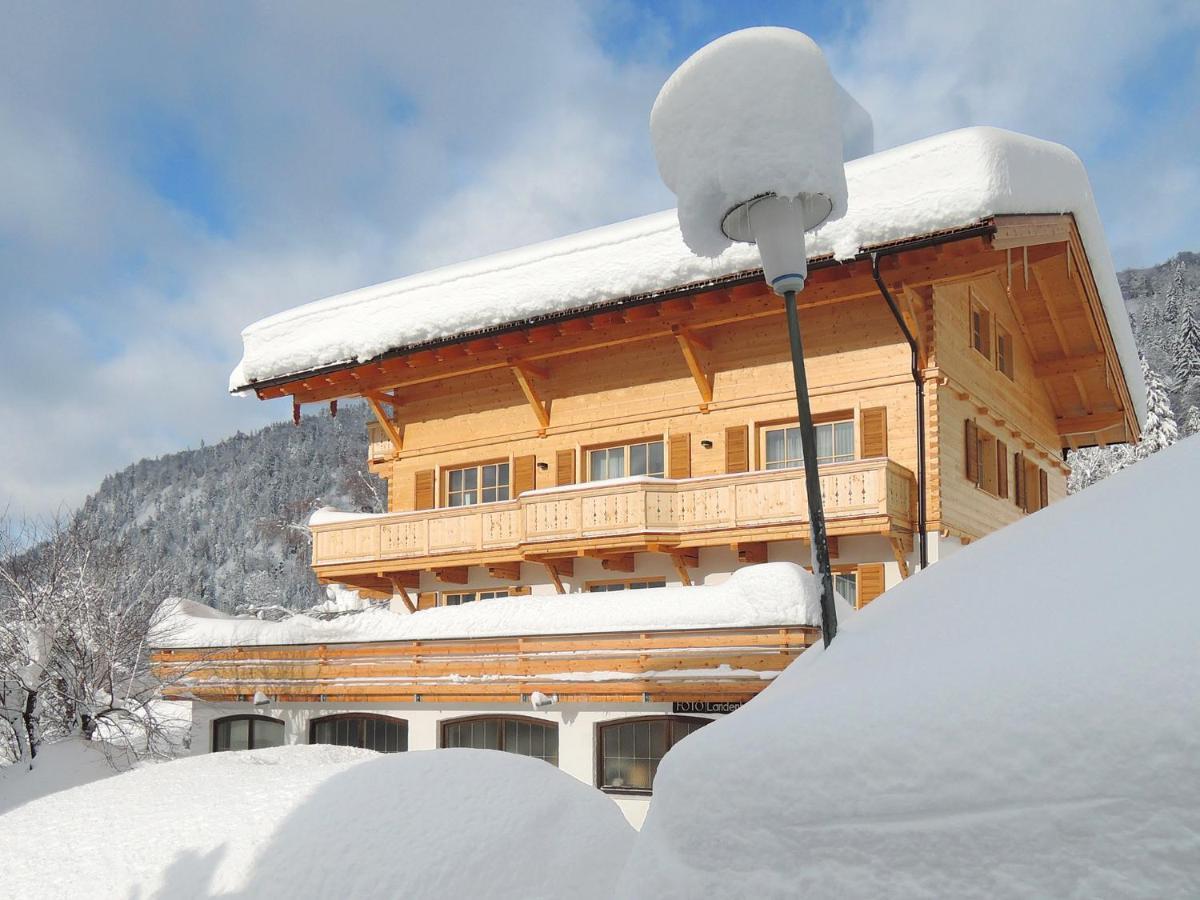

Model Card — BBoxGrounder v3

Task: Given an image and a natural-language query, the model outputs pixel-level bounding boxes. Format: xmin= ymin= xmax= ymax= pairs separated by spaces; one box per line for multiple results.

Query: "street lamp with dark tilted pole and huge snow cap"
xmin=650 ymin=28 xmax=846 ymax=647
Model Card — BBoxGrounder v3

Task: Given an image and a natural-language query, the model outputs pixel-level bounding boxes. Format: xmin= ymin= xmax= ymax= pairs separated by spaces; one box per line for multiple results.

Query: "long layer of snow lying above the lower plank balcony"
xmin=154 ymin=563 xmax=825 ymax=647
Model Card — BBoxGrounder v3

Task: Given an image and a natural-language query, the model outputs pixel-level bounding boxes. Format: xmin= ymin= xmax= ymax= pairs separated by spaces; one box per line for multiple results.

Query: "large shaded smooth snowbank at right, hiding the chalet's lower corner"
xmin=618 ymin=438 xmax=1200 ymax=898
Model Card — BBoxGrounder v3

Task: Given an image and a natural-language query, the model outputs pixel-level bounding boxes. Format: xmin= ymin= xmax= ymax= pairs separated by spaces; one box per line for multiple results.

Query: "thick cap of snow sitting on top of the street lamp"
xmin=650 ymin=28 xmax=846 ymax=257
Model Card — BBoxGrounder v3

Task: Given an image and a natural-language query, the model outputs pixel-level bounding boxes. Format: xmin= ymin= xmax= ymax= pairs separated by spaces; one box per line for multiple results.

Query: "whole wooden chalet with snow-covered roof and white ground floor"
xmin=156 ymin=130 xmax=1145 ymax=822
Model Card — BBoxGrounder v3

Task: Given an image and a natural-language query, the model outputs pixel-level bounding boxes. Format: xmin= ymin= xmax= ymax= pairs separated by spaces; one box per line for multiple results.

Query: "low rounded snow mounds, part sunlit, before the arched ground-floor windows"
xmin=0 ymin=745 xmax=634 ymax=900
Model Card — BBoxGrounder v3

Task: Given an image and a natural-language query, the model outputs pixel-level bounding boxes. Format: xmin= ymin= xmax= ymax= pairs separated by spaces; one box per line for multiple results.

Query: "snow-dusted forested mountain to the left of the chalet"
xmin=78 ymin=403 xmax=385 ymax=611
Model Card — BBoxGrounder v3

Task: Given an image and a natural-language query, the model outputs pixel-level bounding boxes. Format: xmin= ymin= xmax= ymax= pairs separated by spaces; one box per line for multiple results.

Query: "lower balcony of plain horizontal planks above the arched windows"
xmin=151 ymin=628 xmax=821 ymax=703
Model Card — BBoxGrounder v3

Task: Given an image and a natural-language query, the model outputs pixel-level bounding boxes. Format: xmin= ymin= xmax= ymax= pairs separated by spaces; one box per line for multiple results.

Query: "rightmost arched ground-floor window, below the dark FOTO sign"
xmin=596 ymin=715 xmax=710 ymax=793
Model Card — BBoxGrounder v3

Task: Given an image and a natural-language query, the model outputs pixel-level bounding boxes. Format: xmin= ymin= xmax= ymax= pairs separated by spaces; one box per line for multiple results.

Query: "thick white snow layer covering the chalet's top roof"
xmin=229 ymin=127 xmax=1146 ymax=422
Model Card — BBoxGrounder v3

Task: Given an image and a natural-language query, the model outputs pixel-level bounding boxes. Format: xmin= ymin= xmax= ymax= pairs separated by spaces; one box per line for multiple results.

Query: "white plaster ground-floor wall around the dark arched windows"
xmin=192 ymin=702 xmax=716 ymax=828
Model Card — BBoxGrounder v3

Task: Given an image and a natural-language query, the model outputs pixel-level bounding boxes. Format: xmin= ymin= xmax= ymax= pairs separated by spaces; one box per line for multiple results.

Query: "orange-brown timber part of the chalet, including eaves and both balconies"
xmin=156 ymin=215 xmax=1139 ymax=703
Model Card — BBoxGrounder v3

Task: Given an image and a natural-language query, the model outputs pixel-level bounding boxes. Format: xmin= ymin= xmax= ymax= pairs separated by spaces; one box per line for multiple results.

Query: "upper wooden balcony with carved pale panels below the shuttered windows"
xmin=312 ymin=458 xmax=916 ymax=583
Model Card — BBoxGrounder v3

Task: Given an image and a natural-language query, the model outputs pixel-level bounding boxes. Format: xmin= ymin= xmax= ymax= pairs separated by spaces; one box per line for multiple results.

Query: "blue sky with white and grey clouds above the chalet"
xmin=0 ymin=0 xmax=1200 ymax=515
